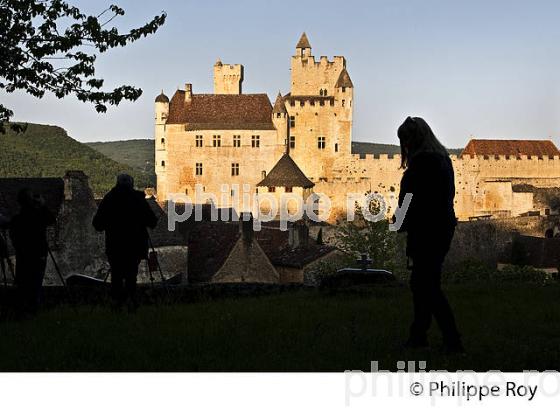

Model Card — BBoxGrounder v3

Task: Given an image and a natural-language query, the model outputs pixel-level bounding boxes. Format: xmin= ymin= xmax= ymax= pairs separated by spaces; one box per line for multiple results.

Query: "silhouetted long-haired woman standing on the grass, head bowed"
xmin=398 ymin=117 xmax=463 ymax=352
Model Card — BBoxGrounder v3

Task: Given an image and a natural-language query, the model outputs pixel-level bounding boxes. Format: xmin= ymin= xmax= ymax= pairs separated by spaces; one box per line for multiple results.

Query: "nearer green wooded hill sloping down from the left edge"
xmin=0 ymin=124 xmax=153 ymax=196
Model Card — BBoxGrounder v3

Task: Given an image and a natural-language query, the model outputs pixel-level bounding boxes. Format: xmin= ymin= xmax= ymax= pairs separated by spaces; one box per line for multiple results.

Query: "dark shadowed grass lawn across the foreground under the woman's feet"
xmin=0 ymin=283 xmax=560 ymax=371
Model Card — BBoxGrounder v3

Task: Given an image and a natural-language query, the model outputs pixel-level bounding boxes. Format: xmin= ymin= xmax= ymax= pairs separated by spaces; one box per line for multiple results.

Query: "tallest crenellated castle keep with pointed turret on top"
xmin=285 ymin=33 xmax=354 ymax=181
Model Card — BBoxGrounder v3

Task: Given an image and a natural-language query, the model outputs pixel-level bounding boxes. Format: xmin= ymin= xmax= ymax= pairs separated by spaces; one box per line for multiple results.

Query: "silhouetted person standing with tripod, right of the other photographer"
xmin=93 ymin=174 xmax=157 ymax=309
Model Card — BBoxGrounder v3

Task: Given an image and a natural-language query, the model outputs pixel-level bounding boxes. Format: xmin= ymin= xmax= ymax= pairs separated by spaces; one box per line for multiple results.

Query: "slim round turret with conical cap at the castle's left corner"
xmin=154 ymin=90 xmax=169 ymax=198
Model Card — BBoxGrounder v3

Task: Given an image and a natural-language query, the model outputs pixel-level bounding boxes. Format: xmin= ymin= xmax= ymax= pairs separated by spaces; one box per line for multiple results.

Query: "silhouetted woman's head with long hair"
xmin=397 ymin=117 xmax=449 ymax=168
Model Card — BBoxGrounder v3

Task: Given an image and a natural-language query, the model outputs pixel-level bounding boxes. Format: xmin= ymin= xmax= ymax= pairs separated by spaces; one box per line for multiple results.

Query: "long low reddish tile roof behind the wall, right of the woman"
xmin=461 ymin=139 xmax=560 ymax=157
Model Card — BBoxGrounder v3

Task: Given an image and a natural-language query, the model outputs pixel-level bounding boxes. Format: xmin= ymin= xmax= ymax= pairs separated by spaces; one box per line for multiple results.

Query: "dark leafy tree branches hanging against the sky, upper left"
xmin=0 ymin=0 xmax=166 ymax=132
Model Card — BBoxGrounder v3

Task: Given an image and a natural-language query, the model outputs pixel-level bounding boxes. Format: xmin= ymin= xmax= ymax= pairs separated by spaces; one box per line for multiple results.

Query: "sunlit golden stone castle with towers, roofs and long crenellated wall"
xmin=155 ymin=33 xmax=560 ymax=220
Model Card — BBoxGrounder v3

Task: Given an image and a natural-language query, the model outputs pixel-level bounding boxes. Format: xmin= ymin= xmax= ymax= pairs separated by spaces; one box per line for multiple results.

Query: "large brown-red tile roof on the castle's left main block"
xmin=167 ymin=90 xmax=274 ymax=130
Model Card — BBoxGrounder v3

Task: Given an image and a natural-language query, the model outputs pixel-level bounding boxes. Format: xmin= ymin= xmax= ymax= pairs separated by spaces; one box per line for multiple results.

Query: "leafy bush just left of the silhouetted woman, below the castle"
xmin=334 ymin=196 xmax=402 ymax=270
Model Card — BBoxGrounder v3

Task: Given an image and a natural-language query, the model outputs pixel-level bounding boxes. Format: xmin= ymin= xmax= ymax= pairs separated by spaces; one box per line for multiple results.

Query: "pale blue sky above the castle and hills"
xmin=0 ymin=0 xmax=560 ymax=147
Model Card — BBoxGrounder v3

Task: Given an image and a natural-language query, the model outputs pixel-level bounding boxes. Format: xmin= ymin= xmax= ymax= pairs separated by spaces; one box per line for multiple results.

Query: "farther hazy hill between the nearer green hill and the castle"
xmin=86 ymin=139 xmax=156 ymax=186
